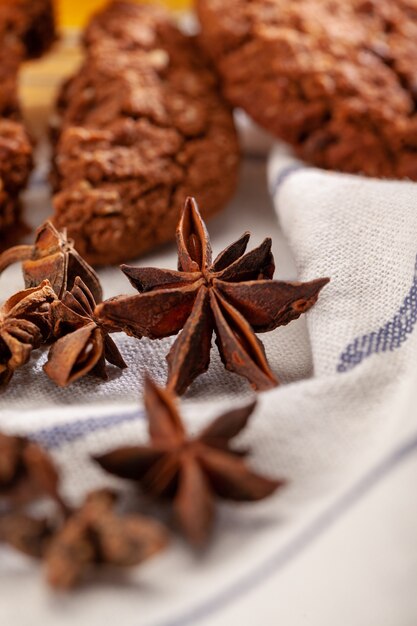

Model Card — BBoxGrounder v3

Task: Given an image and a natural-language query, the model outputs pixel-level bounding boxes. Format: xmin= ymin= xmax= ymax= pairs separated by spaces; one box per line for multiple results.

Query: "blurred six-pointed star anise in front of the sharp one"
xmin=95 ymin=379 xmax=285 ymax=545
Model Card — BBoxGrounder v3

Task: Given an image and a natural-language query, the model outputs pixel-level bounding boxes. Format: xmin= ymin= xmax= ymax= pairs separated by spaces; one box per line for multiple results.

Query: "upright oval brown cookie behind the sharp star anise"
xmin=53 ymin=2 xmax=239 ymax=265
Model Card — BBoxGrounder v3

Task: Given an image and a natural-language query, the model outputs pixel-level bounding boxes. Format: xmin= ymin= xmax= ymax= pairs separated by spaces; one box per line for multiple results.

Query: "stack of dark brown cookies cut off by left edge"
xmin=0 ymin=0 xmax=55 ymax=244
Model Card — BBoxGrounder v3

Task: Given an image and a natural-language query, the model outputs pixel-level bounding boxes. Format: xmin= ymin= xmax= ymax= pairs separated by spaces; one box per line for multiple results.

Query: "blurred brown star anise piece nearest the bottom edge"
xmin=45 ymin=489 xmax=167 ymax=589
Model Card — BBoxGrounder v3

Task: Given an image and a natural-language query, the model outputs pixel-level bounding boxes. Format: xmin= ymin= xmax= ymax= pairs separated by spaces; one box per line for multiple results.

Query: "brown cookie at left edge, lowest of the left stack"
xmin=0 ymin=119 xmax=32 ymax=236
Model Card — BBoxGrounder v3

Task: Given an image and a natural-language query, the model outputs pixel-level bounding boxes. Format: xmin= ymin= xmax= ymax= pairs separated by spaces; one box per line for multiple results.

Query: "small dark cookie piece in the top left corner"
xmin=0 ymin=0 xmax=56 ymax=58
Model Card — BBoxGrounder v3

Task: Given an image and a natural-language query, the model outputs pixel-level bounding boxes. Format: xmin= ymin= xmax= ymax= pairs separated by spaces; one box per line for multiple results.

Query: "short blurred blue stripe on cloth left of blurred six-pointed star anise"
xmin=29 ymin=410 xmax=145 ymax=449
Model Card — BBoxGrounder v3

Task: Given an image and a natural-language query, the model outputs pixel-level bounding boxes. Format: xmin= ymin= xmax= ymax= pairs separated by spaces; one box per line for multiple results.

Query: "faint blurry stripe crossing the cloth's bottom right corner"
xmin=144 ymin=433 xmax=417 ymax=626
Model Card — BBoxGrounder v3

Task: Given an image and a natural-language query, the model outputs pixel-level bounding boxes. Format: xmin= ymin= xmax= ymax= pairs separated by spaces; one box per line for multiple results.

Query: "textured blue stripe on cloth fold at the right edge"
xmin=337 ymin=252 xmax=417 ymax=372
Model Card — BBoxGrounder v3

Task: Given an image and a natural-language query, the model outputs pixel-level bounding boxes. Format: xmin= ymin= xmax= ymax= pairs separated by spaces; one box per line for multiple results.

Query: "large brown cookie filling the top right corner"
xmin=196 ymin=0 xmax=417 ymax=180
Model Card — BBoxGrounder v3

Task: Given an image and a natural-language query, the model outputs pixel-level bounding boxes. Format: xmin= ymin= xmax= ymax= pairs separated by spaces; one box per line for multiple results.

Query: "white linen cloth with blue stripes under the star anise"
xmin=0 ymin=134 xmax=417 ymax=626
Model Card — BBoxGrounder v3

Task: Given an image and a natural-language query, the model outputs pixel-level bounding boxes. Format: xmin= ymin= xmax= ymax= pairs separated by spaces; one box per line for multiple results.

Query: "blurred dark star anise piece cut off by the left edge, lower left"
xmin=0 ymin=432 xmax=61 ymax=508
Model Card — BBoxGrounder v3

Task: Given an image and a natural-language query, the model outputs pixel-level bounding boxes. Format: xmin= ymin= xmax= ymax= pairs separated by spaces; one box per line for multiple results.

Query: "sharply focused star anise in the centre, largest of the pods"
xmin=96 ymin=198 xmax=329 ymax=394
